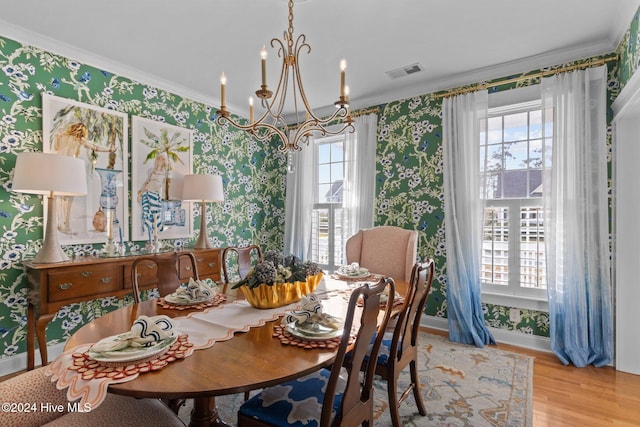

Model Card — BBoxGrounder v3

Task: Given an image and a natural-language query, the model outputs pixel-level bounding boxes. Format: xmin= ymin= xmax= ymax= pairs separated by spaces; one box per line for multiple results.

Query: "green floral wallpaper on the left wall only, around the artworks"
xmin=0 ymin=37 xmax=286 ymax=357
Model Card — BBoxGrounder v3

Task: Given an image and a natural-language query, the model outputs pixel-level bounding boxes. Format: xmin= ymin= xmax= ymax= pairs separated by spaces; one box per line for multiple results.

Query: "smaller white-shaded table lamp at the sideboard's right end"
xmin=182 ymin=174 xmax=224 ymax=249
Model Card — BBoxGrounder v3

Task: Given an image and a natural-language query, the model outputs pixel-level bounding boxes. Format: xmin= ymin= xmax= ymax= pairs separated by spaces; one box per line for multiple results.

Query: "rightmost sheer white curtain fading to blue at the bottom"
xmin=542 ymin=66 xmax=613 ymax=366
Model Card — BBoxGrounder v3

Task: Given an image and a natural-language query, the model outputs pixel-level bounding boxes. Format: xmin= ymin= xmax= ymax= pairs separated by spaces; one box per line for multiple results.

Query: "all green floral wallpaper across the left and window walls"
xmin=0 ymin=2 xmax=640 ymax=357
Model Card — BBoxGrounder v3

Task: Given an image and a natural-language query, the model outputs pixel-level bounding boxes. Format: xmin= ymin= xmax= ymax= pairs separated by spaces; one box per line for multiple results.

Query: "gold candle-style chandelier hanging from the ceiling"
xmin=216 ymin=0 xmax=355 ymax=152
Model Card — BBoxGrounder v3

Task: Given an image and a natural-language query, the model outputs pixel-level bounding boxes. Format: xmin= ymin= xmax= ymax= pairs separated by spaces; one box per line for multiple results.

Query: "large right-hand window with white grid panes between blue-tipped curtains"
xmin=480 ymin=101 xmax=552 ymax=299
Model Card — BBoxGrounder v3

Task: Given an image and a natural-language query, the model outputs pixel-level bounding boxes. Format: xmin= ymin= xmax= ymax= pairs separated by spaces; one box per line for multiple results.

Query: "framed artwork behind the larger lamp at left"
xmin=42 ymin=93 xmax=129 ymax=245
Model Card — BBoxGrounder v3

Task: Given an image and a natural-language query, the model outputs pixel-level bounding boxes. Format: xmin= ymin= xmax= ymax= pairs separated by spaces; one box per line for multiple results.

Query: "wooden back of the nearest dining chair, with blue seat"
xmin=320 ymin=278 xmax=395 ymax=426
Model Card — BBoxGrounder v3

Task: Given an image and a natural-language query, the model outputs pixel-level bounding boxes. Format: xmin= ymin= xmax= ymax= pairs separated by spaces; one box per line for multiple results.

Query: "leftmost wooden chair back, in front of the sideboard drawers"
xmin=131 ymin=252 xmax=200 ymax=303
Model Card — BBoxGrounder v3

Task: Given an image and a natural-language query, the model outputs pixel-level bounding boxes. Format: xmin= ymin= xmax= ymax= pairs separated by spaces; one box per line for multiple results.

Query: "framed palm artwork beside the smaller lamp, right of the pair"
xmin=131 ymin=116 xmax=193 ymax=241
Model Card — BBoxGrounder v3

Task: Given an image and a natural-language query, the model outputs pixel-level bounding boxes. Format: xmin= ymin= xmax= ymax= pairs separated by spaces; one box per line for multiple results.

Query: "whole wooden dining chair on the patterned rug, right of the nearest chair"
xmin=376 ymin=259 xmax=434 ymax=427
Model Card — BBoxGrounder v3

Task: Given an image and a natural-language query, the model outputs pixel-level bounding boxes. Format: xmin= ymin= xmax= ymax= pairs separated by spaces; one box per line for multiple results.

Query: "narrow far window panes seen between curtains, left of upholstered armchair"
xmin=311 ymin=135 xmax=346 ymax=271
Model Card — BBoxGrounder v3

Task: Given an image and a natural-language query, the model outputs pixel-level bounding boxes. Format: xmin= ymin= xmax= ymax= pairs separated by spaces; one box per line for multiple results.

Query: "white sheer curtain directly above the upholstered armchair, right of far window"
xmin=343 ymin=114 xmax=378 ymax=237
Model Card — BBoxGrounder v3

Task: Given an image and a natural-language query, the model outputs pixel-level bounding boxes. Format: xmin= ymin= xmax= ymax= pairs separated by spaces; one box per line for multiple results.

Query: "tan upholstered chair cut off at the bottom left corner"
xmin=0 ymin=367 xmax=184 ymax=427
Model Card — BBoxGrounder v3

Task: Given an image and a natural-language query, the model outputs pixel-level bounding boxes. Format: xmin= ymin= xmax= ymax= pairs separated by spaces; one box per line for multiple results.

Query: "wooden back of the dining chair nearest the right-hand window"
xmin=389 ymin=259 xmax=434 ymax=360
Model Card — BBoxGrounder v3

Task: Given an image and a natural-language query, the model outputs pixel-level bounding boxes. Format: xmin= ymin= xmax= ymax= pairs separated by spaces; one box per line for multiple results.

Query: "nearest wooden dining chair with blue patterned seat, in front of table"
xmin=238 ymin=278 xmax=395 ymax=427
